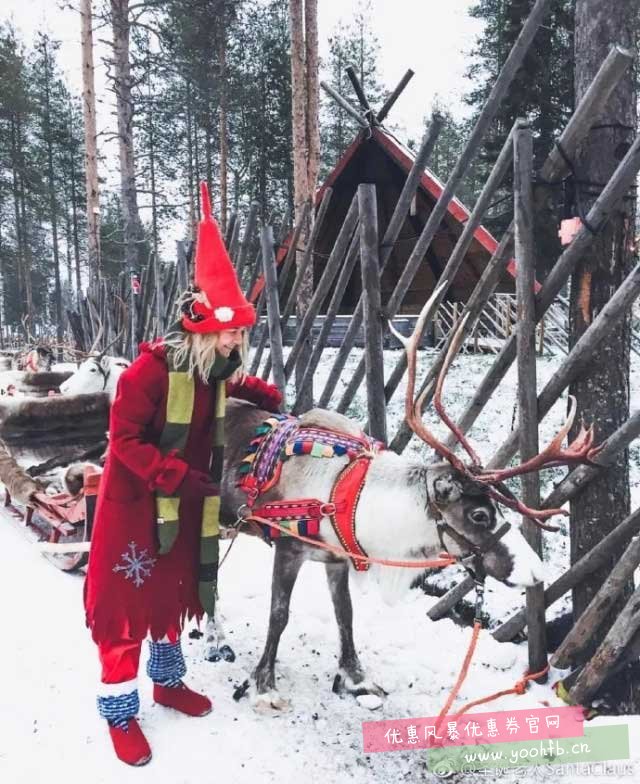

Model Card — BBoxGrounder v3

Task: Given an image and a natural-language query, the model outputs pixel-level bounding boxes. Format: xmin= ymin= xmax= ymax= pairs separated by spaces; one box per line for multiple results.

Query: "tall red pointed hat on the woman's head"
xmin=182 ymin=182 xmax=256 ymax=332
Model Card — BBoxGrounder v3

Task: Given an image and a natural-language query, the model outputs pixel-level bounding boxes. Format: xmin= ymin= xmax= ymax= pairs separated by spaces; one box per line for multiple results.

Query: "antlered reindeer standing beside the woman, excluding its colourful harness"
xmin=215 ymin=292 xmax=599 ymax=711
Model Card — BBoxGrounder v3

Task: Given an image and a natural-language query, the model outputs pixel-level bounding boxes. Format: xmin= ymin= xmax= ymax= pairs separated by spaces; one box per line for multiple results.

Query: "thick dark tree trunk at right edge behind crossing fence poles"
xmin=569 ymin=0 xmax=639 ymax=692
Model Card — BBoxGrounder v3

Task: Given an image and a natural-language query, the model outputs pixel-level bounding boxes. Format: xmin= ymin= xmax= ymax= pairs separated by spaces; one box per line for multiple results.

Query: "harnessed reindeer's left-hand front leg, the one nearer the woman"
xmin=253 ymin=541 xmax=305 ymax=712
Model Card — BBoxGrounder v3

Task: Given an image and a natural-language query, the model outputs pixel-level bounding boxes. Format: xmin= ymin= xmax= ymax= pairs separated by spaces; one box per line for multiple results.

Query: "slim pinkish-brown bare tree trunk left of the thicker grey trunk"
xmin=76 ymin=0 xmax=100 ymax=284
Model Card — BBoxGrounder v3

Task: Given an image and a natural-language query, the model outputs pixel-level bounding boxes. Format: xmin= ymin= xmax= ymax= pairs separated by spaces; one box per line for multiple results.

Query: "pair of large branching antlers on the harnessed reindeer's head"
xmin=389 ymin=294 xmax=602 ymax=531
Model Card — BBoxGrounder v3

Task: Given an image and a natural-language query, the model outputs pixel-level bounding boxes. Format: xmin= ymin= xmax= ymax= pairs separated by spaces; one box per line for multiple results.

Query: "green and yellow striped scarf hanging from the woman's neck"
xmin=156 ymin=350 xmax=241 ymax=616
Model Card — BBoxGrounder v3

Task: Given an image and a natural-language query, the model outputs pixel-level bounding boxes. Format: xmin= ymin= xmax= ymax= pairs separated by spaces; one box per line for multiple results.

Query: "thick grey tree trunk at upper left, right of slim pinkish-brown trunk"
xmin=111 ymin=0 xmax=142 ymax=269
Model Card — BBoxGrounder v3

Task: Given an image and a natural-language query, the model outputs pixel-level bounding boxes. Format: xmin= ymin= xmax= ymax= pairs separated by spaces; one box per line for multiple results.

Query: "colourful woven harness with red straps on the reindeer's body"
xmin=238 ymin=414 xmax=385 ymax=571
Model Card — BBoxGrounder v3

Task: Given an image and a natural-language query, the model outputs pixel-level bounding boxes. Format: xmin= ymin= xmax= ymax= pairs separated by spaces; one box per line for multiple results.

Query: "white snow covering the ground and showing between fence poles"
xmin=0 ymin=351 xmax=640 ymax=784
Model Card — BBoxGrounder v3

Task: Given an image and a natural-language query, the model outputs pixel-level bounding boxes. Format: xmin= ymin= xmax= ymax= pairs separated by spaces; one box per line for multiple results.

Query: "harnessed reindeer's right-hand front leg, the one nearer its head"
xmin=325 ymin=561 xmax=387 ymax=709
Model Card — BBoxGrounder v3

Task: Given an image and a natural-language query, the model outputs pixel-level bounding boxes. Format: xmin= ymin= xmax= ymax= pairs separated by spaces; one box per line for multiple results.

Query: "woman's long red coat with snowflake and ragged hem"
xmin=84 ymin=343 xmax=281 ymax=642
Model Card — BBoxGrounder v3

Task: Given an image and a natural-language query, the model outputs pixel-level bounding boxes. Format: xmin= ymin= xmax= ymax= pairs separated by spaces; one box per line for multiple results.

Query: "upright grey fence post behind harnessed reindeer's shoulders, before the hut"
xmin=358 ymin=184 xmax=387 ymax=443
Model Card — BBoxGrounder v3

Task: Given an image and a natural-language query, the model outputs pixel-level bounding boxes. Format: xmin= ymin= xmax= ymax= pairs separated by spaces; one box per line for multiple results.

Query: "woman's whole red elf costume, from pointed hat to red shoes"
xmin=84 ymin=183 xmax=282 ymax=765
